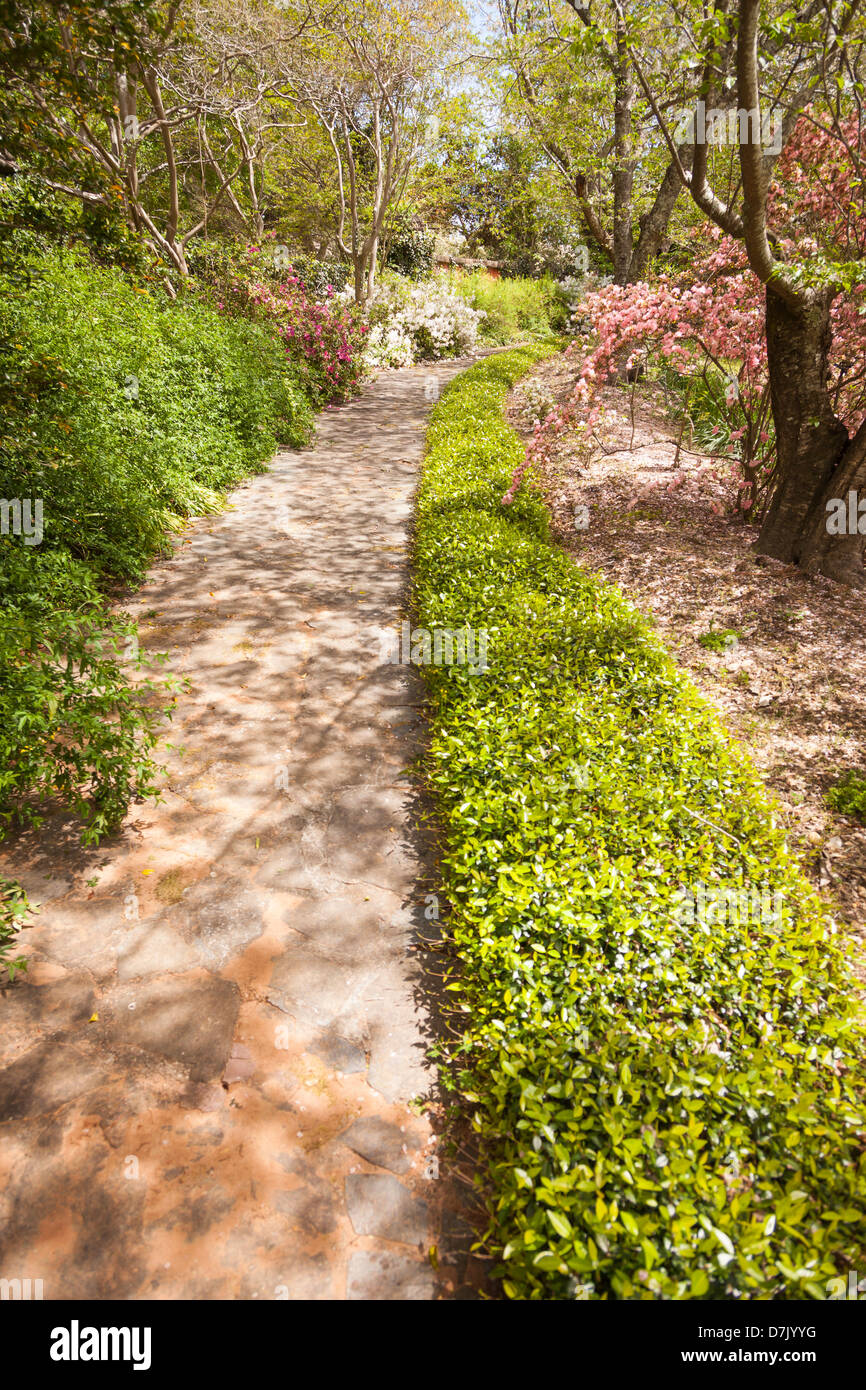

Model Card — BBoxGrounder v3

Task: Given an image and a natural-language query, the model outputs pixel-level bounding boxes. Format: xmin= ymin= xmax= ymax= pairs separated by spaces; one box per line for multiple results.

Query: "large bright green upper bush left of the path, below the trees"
xmin=0 ymin=250 xmax=313 ymax=578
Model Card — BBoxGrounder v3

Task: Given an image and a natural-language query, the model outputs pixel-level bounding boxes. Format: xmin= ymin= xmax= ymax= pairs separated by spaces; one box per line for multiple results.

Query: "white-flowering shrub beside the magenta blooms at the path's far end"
xmin=366 ymin=275 xmax=485 ymax=367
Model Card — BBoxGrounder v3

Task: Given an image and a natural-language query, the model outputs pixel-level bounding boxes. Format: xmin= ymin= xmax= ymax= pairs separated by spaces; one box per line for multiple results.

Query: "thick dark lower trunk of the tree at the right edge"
xmin=758 ymin=285 xmax=866 ymax=585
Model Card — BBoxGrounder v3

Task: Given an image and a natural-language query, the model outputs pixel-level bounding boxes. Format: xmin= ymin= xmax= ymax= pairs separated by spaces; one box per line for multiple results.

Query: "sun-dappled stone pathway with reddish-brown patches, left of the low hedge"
xmin=0 ymin=363 xmax=480 ymax=1300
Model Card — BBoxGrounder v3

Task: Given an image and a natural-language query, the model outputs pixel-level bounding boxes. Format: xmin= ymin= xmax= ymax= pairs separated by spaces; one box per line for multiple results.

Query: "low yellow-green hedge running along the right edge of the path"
xmin=414 ymin=349 xmax=866 ymax=1300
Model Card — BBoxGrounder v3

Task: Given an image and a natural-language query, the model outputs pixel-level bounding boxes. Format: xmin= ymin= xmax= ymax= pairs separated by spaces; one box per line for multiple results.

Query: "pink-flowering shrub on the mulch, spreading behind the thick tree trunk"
xmin=502 ymin=118 xmax=866 ymax=516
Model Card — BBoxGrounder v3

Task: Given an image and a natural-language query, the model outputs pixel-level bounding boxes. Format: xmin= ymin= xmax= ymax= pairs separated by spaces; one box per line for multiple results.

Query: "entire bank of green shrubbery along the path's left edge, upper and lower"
xmin=0 ymin=247 xmax=313 ymax=973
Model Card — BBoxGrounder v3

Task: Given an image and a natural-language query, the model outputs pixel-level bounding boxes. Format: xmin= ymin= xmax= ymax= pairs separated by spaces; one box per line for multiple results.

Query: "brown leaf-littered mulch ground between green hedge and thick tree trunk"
xmin=509 ymin=354 xmax=866 ymax=973
